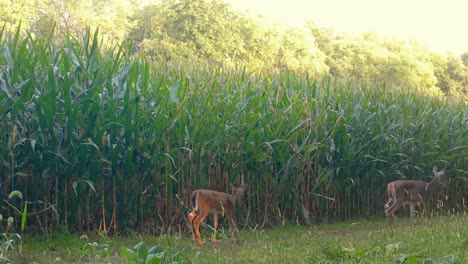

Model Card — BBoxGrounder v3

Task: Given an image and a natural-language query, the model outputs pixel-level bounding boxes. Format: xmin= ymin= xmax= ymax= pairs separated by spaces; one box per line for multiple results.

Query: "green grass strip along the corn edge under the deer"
xmin=13 ymin=213 xmax=468 ymax=263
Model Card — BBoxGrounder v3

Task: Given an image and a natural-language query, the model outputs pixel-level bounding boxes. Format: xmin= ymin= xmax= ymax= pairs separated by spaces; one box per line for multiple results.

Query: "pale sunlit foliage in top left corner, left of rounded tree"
xmin=0 ymin=0 xmax=136 ymax=41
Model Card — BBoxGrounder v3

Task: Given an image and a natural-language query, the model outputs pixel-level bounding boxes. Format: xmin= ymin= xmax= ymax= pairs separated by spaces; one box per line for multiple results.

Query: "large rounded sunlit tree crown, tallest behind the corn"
xmin=131 ymin=0 xmax=240 ymax=63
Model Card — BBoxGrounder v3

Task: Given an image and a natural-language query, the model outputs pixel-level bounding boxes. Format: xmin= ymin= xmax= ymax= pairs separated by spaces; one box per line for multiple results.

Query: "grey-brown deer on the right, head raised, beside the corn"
xmin=384 ymin=166 xmax=447 ymax=228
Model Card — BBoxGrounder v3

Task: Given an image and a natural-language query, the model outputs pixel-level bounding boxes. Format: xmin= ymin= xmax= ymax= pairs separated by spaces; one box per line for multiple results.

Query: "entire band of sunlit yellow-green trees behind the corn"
xmin=0 ymin=0 xmax=468 ymax=102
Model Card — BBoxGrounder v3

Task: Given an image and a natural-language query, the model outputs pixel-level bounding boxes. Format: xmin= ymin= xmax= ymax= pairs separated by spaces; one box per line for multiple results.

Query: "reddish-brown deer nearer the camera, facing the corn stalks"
xmin=188 ymin=184 xmax=247 ymax=249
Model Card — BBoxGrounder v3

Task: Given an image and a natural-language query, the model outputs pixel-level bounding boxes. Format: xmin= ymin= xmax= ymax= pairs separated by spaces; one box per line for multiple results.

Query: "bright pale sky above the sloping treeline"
xmin=225 ymin=0 xmax=468 ymax=55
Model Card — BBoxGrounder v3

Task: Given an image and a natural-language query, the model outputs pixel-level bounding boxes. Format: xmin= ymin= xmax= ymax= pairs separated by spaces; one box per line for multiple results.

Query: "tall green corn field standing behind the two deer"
xmin=0 ymin=29 xmax=468 ymax=232
